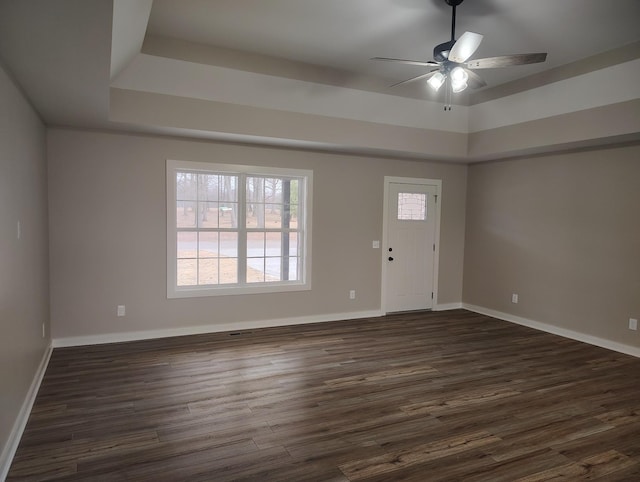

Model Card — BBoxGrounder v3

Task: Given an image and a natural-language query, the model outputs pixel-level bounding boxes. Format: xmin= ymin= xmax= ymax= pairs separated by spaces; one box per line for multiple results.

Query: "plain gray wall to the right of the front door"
xmin=463 ymin=146 xmax=640 ymax=346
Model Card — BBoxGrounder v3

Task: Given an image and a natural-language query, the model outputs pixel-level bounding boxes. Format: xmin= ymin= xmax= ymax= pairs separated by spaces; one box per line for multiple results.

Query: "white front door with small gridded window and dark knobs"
xmin=383 ymin=182 xmax=438 ymax=312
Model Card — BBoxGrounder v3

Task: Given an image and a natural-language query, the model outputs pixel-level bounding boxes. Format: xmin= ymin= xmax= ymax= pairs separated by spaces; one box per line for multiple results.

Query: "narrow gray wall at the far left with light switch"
xmin=0 ymin=66 xmax=49 ymax=462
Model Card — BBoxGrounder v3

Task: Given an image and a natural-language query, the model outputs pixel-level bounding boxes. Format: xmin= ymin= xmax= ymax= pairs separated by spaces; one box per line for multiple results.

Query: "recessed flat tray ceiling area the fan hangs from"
xmin=148 ymin=0 xmax=640 ymax=91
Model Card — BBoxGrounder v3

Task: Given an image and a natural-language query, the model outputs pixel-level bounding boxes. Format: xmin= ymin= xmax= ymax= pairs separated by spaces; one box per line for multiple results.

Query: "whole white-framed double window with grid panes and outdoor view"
xmin=167 ymin=161 xmax=312 ymax=298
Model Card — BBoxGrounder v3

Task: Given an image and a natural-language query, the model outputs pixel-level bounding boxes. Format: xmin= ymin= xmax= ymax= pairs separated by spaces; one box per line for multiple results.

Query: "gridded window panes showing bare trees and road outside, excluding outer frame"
xmin=175 ymin=171 xmax=304 ymax=286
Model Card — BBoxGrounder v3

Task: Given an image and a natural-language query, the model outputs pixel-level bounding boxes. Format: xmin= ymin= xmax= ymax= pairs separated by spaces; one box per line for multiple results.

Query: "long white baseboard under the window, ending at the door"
xmin=52 ymin=310 xmax=384 ymax=348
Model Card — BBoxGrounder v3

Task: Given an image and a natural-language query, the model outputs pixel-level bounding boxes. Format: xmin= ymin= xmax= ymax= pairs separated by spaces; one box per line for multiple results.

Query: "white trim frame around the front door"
xmin=380 ymin=176 xmax=442 ymax=314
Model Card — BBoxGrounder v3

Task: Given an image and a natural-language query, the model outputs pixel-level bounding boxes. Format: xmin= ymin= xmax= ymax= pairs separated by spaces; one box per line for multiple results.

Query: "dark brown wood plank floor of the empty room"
xmin=8 ymin=310 xmax=640 ymax=482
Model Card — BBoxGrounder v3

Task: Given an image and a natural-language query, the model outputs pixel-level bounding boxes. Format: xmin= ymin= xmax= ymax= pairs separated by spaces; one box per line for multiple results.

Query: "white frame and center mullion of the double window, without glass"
xmin=167 ymin=159 xmax=313 ymax=298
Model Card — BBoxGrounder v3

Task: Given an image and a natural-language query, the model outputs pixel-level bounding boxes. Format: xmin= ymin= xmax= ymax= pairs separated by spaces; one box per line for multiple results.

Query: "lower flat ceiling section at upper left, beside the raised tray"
xmin=0 ymin=0 xmax=112 ymax=125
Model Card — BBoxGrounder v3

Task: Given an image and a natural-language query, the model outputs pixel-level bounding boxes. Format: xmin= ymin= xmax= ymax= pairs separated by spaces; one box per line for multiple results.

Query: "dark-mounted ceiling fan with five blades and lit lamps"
xmin=371 ymin=0 xmax=547 ymax=102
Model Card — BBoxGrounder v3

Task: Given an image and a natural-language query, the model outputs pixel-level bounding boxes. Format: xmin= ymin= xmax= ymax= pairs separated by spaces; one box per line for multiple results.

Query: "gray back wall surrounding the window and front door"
xmin=48 ymin=129 xmax=467 ymax=338
